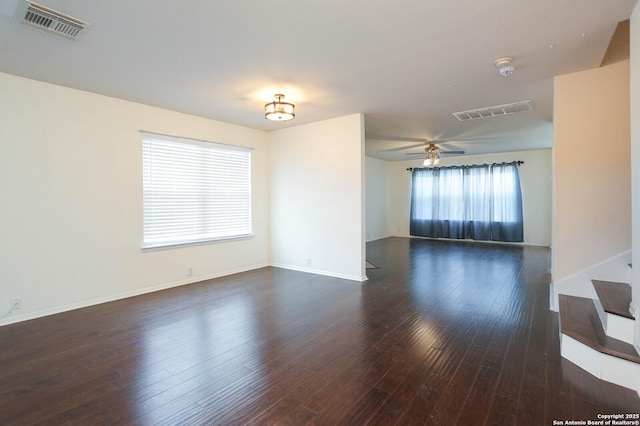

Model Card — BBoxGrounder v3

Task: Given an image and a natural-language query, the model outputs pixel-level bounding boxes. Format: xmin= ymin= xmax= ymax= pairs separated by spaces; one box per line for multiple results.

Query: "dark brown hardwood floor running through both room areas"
xmin=0 ymin=238 xmax=640 ymax=425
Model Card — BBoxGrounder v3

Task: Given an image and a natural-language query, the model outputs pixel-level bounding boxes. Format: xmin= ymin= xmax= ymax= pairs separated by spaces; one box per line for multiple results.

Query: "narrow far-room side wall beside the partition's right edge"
xmin=365 ymin=157 xmax=389 ymax=241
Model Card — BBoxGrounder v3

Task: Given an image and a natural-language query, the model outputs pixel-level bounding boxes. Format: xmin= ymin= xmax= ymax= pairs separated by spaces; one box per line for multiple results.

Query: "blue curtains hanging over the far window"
xmin=410 ymin=162 xmax=523 ymax=242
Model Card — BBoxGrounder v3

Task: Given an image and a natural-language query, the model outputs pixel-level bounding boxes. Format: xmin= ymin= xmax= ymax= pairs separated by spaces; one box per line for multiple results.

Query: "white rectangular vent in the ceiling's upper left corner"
xmin=16 ymin=0 xmax=87 ymax=40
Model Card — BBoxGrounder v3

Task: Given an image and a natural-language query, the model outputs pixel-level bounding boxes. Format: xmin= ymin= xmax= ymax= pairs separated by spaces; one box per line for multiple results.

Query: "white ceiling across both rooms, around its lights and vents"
xmin=0 ymin=0 xmax=637 ymax=160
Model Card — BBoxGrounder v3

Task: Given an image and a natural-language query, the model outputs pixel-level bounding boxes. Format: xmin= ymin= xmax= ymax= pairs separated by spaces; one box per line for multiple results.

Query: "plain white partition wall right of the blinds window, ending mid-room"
xmin=270 ymin=114 xmax=366 ymax=281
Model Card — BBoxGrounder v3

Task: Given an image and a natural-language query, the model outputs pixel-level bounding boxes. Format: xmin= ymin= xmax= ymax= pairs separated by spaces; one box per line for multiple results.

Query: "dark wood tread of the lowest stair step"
xmin=559 ymin=294 xmax=640 ymax=364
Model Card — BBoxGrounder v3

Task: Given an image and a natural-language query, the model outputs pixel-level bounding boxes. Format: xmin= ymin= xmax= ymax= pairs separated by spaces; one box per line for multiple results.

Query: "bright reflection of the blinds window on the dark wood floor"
xmin=132 ymin=291 xmax=263 ymax=424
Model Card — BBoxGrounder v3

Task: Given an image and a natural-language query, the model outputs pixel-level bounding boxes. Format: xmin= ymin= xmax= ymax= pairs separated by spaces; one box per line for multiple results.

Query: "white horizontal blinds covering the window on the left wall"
xmin=142 ymin=133 xmax=251 ymax=248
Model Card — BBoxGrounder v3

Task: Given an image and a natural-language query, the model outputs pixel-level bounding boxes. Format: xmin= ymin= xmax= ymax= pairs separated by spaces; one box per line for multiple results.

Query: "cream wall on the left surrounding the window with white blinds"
xmin=0 ymin=74 xmax=269 ymax=324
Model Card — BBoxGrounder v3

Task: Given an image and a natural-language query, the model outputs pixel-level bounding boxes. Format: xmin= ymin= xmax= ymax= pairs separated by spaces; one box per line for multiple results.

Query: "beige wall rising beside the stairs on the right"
xmin=552 ymin=61 xmax=631 ymax=285
